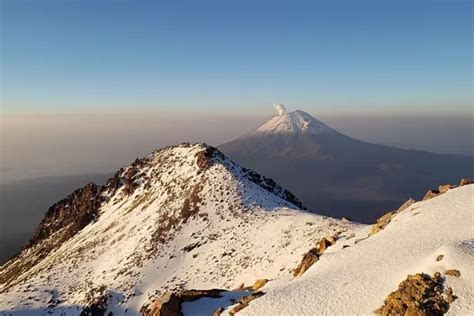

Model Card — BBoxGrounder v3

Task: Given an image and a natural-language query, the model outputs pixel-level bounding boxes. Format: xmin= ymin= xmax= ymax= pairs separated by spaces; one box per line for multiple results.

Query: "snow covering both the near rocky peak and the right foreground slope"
xmin=0 ymin=142 xmax=474 ymax=316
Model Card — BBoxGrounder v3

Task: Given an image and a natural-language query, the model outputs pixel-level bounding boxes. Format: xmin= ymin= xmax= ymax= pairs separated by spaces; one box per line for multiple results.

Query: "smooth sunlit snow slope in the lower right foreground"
xmin=239 ymin=185 xmax=474 ymax=316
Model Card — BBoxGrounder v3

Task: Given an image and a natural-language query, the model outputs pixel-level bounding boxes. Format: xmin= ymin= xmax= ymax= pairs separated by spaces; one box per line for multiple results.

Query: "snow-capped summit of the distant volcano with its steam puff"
xmin=253 ymin=104 xmax=338 ymax=135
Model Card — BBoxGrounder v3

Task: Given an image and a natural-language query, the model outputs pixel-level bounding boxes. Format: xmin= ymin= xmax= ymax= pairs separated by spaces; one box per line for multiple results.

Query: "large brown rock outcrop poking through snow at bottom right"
xmin=376 ymin=272 xmax=456 ymax=316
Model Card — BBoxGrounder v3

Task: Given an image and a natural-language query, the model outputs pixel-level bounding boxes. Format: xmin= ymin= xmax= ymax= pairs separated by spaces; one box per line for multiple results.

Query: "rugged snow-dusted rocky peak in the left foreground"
xmin=0 ymin=144 xmax=354 ymax=315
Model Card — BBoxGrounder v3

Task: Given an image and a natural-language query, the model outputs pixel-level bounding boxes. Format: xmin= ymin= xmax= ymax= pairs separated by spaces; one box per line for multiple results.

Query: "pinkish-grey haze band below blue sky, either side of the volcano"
xmin=0 ymin=106 xmax=474 ymax=183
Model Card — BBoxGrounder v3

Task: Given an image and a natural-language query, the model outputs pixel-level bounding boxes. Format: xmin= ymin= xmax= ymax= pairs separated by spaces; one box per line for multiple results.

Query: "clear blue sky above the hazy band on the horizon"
xmin=1 ymin=0 xmax=473 ymax=113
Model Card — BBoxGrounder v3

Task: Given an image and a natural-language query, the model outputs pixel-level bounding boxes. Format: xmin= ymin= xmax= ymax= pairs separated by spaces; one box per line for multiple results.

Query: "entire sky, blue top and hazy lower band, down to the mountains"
xmin=0 ymin=0 xmax=474 ymax=182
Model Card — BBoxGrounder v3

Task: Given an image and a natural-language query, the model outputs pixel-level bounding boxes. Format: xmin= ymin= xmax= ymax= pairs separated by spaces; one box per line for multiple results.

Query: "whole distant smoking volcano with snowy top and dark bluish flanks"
xmin=218 ymin=105 xmax=474 ymax=222
